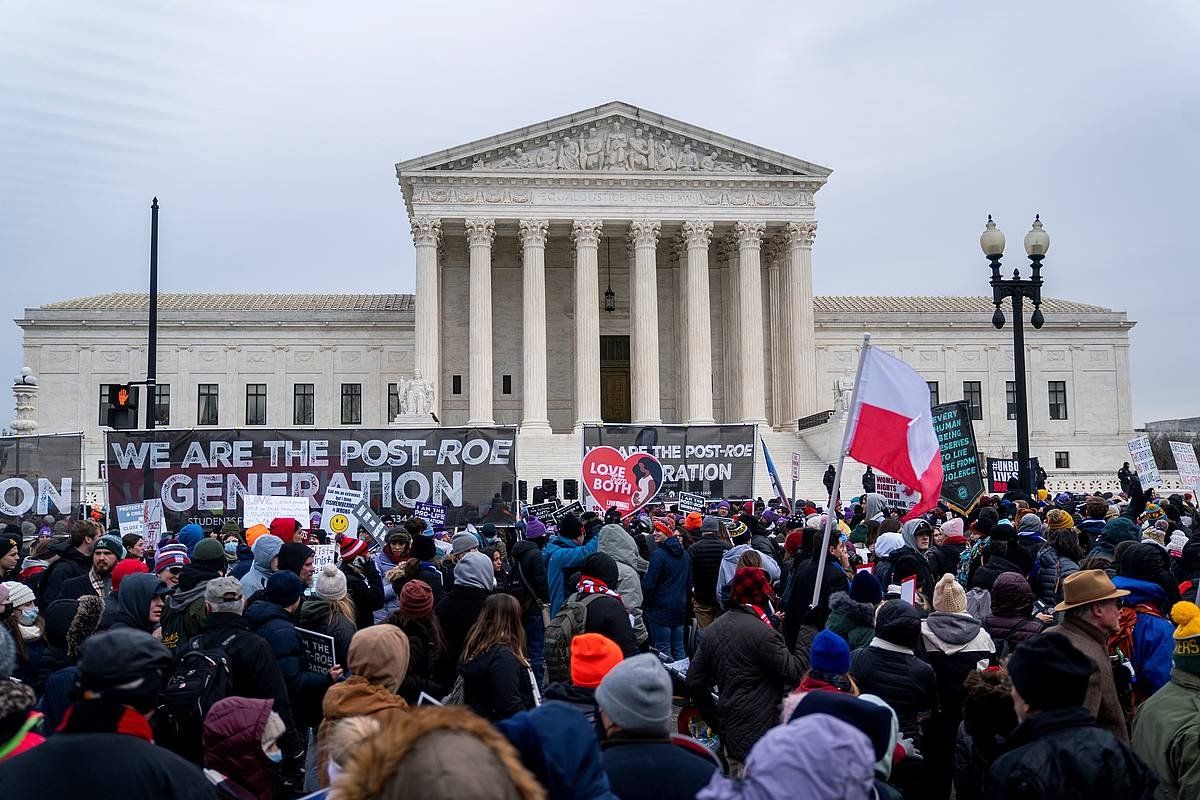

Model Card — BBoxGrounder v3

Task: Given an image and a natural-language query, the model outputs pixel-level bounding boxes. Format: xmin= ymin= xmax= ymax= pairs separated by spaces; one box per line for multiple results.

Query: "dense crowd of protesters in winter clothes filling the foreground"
xmin=0 ymin=475 xmax=1200 ymax=800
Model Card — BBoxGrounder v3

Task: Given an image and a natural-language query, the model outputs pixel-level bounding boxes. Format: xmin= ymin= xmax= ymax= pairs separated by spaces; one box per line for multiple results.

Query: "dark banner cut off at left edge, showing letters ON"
xmin=0 ymin=433 xmax=82 ymax=521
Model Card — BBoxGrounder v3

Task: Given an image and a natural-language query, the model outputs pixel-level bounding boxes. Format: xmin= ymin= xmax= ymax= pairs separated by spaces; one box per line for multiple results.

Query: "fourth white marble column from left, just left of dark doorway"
xmin=571 ymin=219 xmax=604 ymax=428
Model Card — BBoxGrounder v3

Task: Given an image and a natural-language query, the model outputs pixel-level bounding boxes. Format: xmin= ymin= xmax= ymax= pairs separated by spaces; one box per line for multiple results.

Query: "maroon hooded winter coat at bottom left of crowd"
xmin=202 ymin=695 xmax=278 ymax=800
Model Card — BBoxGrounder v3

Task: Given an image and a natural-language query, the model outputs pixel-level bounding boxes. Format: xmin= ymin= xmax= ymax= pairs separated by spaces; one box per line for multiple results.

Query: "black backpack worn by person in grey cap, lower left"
xmin=152 ymin=632 xmax=238 ymax=765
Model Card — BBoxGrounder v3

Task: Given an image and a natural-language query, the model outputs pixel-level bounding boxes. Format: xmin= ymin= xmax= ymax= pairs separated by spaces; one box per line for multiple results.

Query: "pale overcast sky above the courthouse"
xmin=0 ymin=0 xmax=1200 ymax=426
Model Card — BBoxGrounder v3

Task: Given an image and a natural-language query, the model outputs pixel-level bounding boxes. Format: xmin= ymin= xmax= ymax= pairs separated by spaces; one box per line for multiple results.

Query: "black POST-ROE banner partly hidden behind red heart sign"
xmin=583 ymin=425 xmax=755 ymax=503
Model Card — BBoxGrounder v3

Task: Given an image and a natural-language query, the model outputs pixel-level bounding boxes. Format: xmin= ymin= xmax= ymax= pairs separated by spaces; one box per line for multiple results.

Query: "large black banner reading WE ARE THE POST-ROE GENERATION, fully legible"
xmin=106 ymin=427 xmax=516 ymax=530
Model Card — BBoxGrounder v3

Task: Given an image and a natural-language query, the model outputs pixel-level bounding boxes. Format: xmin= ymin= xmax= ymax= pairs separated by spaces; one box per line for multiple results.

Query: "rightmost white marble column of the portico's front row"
xmin=786 ymin=221 xmax=821 ymax=422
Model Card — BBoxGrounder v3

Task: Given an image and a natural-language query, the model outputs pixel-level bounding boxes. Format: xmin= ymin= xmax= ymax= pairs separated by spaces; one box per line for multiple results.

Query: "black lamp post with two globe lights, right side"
xmin=979 ymin=215 xmax=1050 ymax=494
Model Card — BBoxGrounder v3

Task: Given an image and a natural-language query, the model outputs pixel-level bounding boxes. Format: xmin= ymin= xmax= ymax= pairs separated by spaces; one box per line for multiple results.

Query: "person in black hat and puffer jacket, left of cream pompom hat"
xmin=850 ymin=600 xmax=937 ymax=739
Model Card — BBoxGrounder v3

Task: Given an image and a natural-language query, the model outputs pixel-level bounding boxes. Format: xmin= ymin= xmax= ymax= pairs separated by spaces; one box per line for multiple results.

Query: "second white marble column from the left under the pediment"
xmin=464 ymin=217 xmax=496 ymax=426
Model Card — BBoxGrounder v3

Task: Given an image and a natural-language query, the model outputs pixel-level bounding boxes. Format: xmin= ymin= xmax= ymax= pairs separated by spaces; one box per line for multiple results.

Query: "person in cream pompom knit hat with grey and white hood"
xmin=920 ymin=573 xmax=996 ymax=800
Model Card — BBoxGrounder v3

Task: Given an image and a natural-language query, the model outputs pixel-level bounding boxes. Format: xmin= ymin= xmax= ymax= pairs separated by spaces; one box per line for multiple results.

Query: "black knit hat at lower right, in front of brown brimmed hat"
xmin=1008 ymin=633 xmax=1096 ymax=711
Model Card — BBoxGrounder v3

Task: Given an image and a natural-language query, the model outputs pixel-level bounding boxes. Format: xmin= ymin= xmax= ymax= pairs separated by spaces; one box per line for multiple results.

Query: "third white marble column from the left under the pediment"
xmin=518 ymin=219 xmax=550 ymax=433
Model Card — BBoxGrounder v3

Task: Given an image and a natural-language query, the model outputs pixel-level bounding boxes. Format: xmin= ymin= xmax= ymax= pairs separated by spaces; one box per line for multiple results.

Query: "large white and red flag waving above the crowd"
xmin=846 ymin=347 xmax=942 ymax=519
